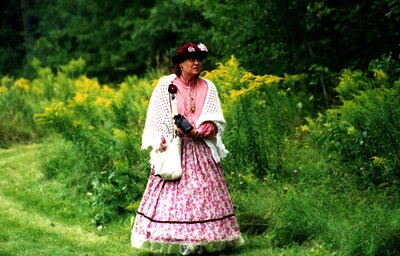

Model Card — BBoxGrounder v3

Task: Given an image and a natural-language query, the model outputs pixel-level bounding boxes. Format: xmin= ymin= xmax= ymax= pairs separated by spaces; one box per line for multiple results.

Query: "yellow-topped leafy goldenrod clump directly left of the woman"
xmin=35 ymin=72 xmax=152 ymax=225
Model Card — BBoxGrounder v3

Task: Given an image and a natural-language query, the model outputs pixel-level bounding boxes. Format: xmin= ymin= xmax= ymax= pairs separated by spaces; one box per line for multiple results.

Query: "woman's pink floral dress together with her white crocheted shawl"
xmin=131 ymin=75 xmax=243 ymax=255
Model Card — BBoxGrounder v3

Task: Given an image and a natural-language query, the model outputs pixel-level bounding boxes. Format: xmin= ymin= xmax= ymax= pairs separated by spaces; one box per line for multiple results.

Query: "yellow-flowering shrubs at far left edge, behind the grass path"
xmin=0 ymin=59 xmax=89 ymax=145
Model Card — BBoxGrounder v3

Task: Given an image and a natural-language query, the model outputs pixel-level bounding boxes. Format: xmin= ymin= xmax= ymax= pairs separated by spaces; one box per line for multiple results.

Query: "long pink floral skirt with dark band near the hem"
xmin=131 ymin=138 xmax=243 ymax=255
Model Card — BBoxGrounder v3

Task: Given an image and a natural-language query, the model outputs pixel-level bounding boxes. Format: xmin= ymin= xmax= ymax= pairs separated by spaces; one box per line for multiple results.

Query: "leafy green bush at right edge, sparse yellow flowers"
xmin=310 ymin=65 xmax=400 ymax=188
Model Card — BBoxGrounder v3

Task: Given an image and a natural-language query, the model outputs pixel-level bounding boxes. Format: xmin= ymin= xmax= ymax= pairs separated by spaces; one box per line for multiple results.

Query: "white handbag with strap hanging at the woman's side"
xmin=150 ymin=84 xmax=182 ymax=180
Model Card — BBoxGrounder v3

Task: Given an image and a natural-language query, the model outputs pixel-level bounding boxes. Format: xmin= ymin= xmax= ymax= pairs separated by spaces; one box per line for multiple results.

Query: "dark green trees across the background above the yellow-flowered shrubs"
xmin=0 ymin=0 xmax=400 ymax=83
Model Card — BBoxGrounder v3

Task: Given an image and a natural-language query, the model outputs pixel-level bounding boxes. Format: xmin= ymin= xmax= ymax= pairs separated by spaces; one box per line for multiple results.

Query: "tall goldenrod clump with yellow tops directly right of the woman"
xmin=205 ymin=57 xmax=311 ymax=180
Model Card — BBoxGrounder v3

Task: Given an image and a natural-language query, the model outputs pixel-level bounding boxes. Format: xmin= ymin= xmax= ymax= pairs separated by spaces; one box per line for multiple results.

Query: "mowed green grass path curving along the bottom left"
xmin=0 ymin=144 xmax=315 ymax=256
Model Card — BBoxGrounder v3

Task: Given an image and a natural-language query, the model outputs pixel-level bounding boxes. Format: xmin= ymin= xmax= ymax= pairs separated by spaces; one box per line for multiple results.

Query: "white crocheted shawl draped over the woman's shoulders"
xmin=142 ymin=74 xmax=228 ymax=163
